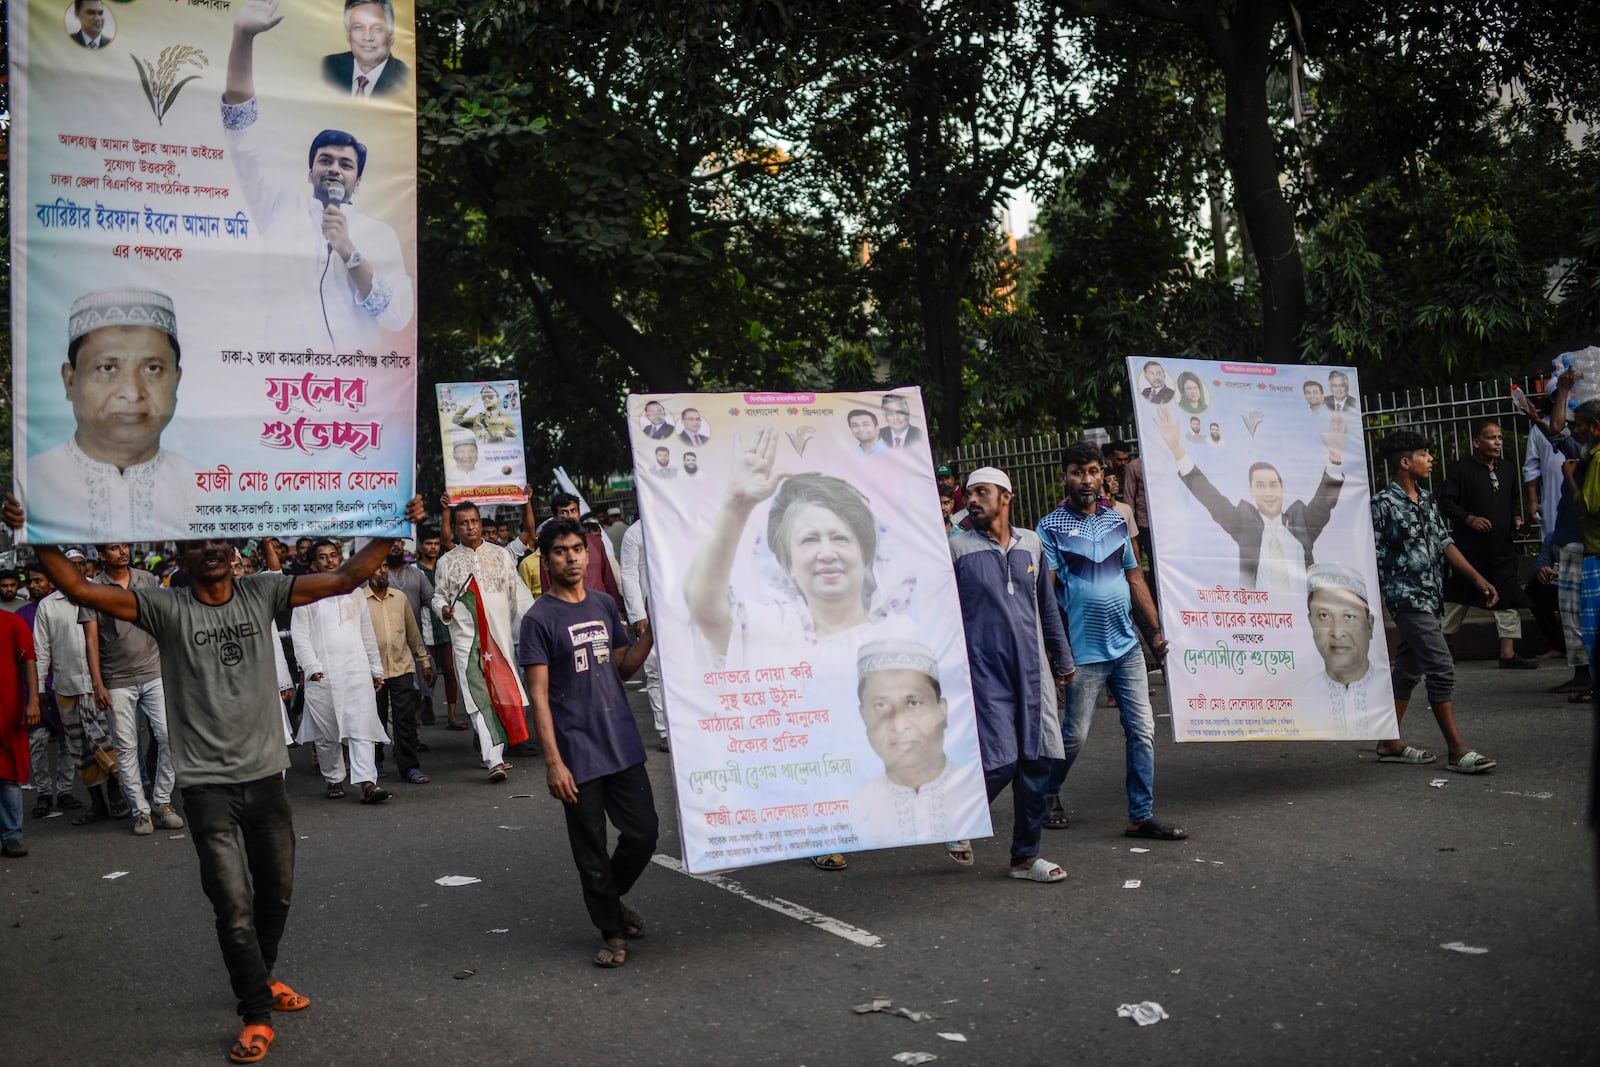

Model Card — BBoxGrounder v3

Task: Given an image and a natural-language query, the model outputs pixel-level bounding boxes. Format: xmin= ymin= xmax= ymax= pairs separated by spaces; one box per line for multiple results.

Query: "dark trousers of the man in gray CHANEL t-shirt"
xmin=181 ymin=774 xmax=294 ymax=1024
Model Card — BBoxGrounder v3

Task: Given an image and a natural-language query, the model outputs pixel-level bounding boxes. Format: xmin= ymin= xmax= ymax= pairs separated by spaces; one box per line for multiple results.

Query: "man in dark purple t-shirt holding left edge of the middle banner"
xmin=517 ymin=518 xmax=659 ymax=966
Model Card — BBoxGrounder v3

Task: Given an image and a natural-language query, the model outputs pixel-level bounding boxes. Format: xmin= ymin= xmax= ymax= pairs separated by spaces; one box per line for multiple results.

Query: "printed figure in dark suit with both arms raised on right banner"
xmin=1157 ymin=408 xmax=1347 ymax=593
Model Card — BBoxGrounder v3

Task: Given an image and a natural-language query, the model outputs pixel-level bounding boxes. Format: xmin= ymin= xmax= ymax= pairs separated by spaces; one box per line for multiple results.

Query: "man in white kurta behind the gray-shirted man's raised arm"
xmin=290 ymin=541 xmax=389 ymax=803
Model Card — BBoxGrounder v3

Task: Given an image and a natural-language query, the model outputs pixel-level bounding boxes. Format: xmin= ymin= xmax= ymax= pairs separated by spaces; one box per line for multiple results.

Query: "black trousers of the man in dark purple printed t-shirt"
xmin=562 ymin=763 xmax=659 ymax=939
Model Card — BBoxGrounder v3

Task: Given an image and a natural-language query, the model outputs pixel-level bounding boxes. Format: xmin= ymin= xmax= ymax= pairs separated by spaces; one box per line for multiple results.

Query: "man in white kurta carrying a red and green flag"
xmin=432 ymin=504 xmax=533 ymax=782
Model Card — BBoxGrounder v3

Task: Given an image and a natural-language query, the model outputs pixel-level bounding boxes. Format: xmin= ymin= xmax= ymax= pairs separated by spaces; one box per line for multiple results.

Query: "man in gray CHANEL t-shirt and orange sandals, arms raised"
xmin=5 ymin=494 xmax=422 ymax=1062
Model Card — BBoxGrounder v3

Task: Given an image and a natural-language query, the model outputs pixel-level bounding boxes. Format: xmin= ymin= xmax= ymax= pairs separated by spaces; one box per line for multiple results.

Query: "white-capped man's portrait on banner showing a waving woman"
xmin=850 ymin=640 xmax=982 ymax=848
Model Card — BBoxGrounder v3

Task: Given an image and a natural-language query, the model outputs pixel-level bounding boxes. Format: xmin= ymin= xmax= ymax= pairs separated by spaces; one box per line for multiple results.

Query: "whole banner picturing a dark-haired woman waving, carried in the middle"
xmin=629 ymin=389 xmax=990 ymax=872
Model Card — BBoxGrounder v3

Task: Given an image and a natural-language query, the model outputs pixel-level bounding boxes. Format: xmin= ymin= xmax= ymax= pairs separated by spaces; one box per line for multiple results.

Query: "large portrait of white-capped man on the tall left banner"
xmin=24 ymin=290 xmax=195 ymax=542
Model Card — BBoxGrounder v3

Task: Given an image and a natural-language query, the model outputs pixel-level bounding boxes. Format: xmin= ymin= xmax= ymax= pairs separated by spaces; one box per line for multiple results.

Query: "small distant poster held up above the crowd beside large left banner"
xmin=435 ymin=382 xmax=528 ymax=504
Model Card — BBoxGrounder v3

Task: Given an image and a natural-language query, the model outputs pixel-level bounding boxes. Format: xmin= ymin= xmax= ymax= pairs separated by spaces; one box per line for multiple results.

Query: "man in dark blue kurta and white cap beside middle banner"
xmin=949 ymin=467 xmax=1074 ymax=881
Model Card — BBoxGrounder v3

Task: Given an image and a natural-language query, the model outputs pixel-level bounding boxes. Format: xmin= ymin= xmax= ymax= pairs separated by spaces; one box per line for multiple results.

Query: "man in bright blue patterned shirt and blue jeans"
xmin=1038 ymin=442 xmax=1189 ymax=841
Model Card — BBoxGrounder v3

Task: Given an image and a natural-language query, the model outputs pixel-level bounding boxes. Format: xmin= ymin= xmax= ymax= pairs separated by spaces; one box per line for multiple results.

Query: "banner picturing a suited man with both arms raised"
xmin=1128 ymin=357 xmax=1395 ymax=741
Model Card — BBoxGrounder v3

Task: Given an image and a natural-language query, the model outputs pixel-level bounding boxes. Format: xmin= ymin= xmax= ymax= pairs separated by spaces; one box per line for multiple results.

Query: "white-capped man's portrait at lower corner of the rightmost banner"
xmin=1294 ymin=563 xmax=1394 ymax=737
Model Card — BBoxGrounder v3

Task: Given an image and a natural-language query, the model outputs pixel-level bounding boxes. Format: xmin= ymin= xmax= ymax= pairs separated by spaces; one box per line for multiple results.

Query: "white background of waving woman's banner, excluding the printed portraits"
xmin=629 ymin=389 xmax=992 ymax=872
